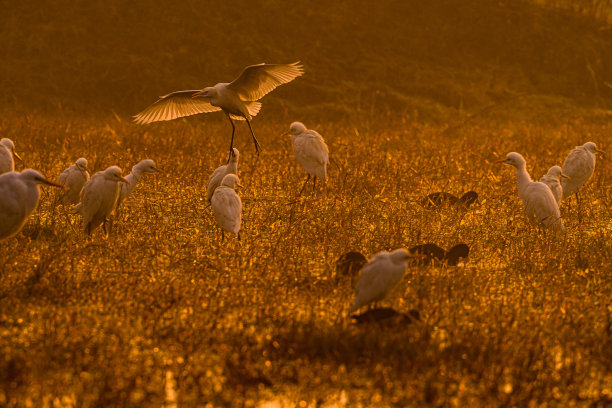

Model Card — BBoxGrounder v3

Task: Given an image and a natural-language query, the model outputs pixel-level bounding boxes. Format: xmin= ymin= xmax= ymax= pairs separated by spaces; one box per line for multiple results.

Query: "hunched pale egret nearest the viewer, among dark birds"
xmin=349 ymin=248 xmax=412 ymax=313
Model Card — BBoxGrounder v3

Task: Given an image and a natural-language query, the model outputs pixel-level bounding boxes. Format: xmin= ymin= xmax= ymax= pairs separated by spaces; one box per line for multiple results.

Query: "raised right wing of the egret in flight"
xmin=227 ymin=61 xmax=304 ymax=101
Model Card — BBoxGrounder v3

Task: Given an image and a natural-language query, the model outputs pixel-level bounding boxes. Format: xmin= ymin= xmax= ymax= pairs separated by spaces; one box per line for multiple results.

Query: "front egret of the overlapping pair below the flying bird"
xmin=210 ymin=174 xmax=242 ymax=239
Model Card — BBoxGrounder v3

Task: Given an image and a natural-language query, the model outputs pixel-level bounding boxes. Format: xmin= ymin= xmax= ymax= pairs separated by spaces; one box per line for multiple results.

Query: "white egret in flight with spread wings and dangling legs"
xmin=134 ymin=61 xmax=304 ymax=155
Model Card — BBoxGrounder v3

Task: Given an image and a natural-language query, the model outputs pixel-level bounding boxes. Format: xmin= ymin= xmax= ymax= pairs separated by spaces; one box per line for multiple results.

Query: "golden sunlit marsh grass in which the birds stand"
xmin=0 ymin=110 xmax=612 ymax=407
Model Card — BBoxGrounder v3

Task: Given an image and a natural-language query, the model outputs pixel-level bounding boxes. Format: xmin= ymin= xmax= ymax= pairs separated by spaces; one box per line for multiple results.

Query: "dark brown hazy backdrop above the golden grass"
xmin=0 ymin=0 xmax=612 ymax=122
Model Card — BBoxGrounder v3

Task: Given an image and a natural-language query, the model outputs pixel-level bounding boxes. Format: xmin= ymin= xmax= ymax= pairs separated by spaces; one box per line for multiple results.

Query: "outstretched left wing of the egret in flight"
xmin=134 ymin=90 xmax=221 ymax=125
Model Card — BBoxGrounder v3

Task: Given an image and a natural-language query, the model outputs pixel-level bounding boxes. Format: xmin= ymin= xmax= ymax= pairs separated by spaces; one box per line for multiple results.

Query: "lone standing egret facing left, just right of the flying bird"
xmin=283 ymin=122 xmax=329 ymax=194
